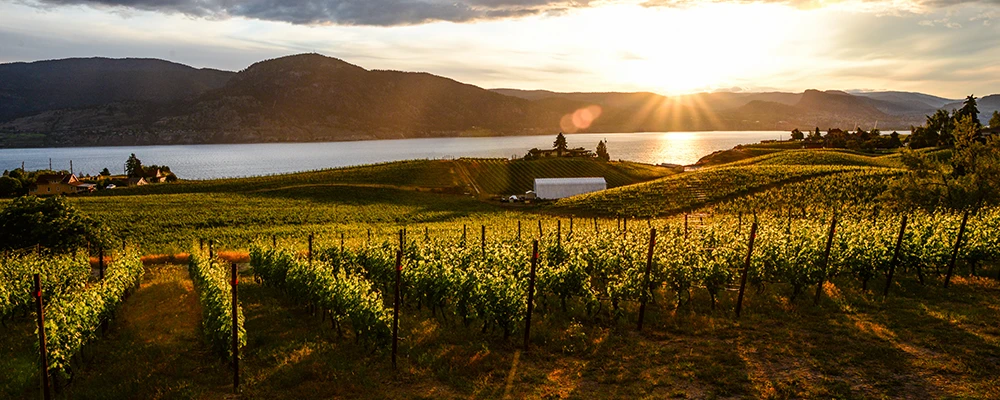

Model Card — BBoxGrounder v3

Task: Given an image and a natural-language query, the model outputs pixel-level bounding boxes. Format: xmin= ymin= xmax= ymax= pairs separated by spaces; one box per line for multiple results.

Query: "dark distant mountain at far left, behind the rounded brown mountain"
xmin=0 ymin=58 xmax=235 ymax=121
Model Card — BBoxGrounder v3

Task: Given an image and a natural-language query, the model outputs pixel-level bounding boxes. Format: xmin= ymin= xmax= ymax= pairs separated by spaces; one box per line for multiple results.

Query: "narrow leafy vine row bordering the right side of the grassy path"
xmin=188 ymin=252 xmax=247 ymax=359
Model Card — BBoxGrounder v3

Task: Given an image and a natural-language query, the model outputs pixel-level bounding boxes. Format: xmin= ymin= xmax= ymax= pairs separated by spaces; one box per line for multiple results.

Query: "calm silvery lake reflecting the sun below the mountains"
xmin=0 ymin=131 xmax=789 ymax=179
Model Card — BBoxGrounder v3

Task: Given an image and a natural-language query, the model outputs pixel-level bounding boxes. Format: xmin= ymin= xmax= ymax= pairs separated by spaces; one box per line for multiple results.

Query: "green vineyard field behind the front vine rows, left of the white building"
xmin=29 ymin=159 xmax=672 ymax=253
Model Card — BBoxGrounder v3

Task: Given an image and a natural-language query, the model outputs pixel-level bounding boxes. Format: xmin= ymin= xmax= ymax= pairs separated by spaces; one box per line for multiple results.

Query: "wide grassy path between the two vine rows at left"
xmin=62 ymin=265 xmax=231 ymax=399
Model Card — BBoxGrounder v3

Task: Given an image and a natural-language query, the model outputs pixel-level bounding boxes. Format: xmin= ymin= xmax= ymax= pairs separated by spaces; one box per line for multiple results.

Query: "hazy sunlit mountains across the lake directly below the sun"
xmin=494 ymin=89 xmax=935 ymax=132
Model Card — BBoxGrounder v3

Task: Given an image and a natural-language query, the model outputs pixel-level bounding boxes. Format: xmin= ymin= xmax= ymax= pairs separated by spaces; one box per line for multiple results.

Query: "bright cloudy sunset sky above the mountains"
xmin=0 ymin=0 xmax=1000 ymax=99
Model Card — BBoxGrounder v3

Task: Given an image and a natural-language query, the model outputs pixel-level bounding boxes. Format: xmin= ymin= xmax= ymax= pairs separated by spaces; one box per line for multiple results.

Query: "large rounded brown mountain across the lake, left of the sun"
xmin=0 ymin=54 xmax=580 ymax=147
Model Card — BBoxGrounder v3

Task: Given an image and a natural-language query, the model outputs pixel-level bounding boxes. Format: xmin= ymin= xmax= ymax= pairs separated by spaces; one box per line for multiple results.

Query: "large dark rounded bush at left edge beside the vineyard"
xmin=0 ymin=196 xmax=106 ymax=252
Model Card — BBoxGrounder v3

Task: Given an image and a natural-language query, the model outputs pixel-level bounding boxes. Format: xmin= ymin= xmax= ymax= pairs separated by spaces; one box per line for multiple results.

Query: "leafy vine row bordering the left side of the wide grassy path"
xmin=42 ymin=250 xmax=143 ymax=377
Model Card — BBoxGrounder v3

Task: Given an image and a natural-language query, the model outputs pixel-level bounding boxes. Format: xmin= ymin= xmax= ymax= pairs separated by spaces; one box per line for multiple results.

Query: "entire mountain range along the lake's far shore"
xmin=0 ymin=54 xmax=1000 ymax=147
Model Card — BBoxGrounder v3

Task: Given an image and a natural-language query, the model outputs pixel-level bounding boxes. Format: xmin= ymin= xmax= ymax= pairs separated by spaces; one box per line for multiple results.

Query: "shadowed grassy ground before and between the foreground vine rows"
xmin=3 ymin=266 xmax=1000 ymax=399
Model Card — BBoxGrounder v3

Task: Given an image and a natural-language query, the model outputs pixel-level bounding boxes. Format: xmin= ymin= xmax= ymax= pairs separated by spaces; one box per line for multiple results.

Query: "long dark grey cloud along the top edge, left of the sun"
xmin=23 ymin=0 xmax=592 ymax=26
